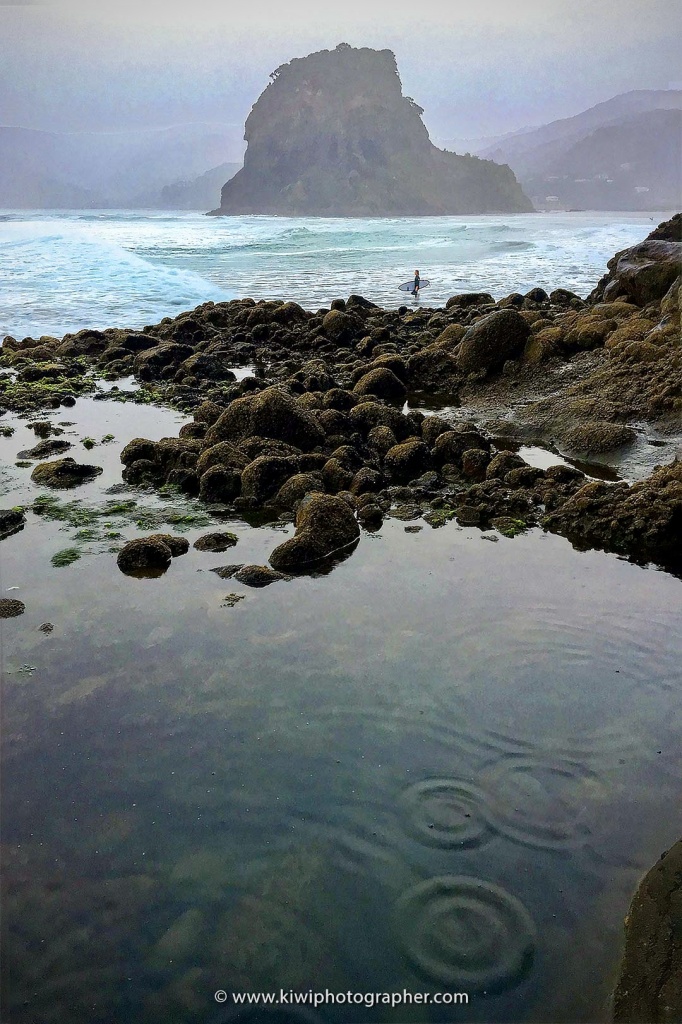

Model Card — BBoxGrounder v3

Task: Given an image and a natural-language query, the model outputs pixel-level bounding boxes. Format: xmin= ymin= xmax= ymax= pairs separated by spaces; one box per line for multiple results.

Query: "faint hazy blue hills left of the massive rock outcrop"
xmin=0 ymin=124 xmax=241 ymax=209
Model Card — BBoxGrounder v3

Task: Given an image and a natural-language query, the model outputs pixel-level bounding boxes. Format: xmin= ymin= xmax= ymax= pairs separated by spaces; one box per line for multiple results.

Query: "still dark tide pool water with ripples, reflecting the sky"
xmin=0 ymin=399 xmax=682 ymax=1024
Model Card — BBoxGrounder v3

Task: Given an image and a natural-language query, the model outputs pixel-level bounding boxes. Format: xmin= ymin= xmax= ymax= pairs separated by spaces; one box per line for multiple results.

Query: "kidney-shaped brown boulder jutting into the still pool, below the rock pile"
xmin=269 ymin=494 xmax=359 ymax=572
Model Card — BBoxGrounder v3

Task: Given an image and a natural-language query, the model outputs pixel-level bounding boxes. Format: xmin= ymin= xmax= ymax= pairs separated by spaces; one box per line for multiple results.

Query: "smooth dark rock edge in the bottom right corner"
xmin=613 ymin=840 xmax=682 ymax=1024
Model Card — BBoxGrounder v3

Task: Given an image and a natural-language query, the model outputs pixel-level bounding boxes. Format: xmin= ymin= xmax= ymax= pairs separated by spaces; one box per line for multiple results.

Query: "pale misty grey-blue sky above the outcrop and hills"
xmin=0 ymin=0 xmax=682 ymax=152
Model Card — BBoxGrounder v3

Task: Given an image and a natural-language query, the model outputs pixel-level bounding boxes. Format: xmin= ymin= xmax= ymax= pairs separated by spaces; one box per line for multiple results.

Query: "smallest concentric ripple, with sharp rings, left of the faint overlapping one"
xmin=402 ymin=778 xmax=491 ymax=849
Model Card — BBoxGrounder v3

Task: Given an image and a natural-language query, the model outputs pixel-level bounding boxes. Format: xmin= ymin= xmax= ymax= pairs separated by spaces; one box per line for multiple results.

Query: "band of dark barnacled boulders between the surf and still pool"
xmin=0 ymin=215 xmax=682 ymax=574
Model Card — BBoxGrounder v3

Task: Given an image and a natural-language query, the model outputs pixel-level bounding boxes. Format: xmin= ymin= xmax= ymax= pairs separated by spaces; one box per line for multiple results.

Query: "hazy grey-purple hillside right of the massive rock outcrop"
xmin=481 ymin=89 xmax=682 ymax=210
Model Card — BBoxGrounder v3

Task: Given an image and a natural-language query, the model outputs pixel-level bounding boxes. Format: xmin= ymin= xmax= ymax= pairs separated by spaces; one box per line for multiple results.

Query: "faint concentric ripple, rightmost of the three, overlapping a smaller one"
xmin=481 ymin=757 xmax=600 ymax=849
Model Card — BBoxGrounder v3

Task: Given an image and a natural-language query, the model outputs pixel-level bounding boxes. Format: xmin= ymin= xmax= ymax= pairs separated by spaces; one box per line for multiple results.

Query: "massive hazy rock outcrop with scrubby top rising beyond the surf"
xmin=212 ymin=43 xmax=532 ymax=217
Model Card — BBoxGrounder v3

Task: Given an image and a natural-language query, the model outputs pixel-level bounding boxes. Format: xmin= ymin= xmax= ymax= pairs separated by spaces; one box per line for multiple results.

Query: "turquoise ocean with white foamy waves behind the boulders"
xmin=0 ymin=210 xmax=669 ymax=339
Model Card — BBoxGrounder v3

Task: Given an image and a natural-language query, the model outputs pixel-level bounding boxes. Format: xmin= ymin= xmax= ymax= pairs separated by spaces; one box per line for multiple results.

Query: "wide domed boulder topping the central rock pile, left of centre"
xmin=201 ymin=387 xmax=325 ymax=452
